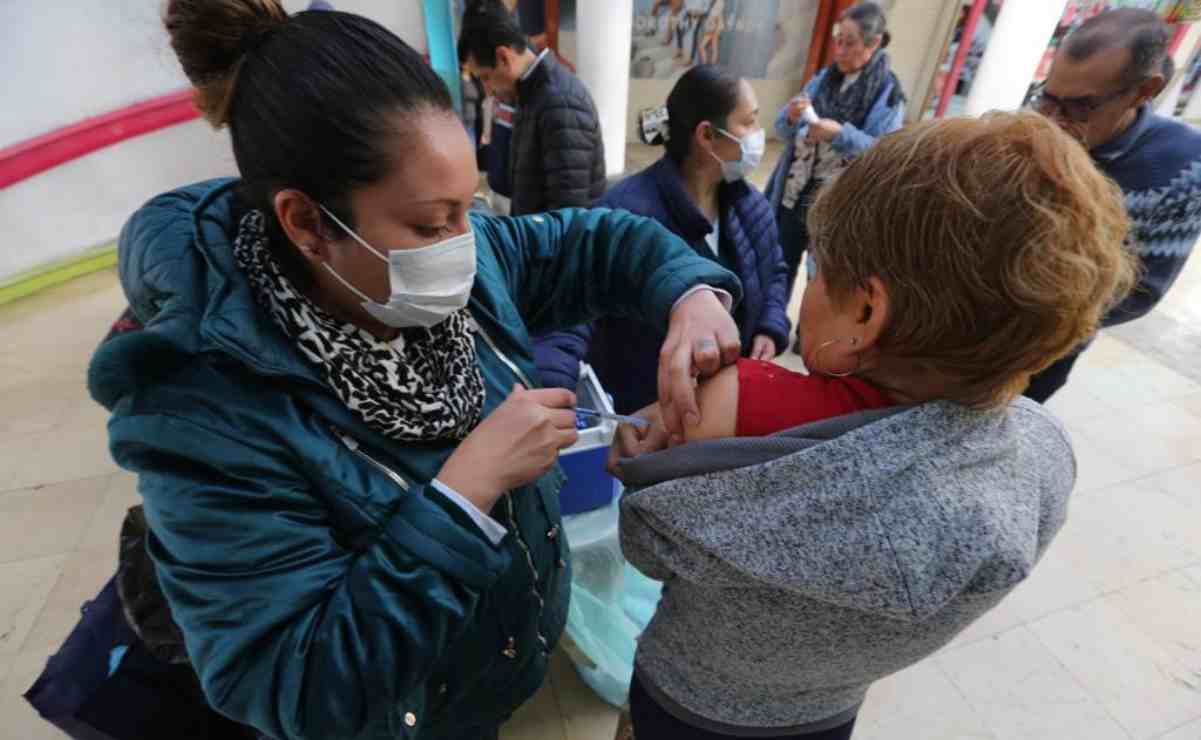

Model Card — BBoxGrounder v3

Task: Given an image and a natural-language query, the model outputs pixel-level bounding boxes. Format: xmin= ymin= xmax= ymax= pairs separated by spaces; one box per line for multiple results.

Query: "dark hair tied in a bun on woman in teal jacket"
xmin=163 ymin=0 xmax=453 ymax=286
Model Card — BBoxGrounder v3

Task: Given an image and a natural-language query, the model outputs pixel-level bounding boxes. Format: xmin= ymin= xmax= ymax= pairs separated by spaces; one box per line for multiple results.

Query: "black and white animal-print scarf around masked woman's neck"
xmin=233 ymin=210 xmax=484 ymax=442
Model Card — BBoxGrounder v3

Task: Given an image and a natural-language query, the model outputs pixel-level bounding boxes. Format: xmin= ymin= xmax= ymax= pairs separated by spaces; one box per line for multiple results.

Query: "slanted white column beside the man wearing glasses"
xmin=966 ymin=0 xmax=1068 ymax=115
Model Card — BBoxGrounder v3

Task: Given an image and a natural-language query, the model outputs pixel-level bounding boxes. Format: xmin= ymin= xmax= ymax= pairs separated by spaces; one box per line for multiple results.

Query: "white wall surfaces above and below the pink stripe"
xmin=0 ymin=0 xmax=425 ymax=281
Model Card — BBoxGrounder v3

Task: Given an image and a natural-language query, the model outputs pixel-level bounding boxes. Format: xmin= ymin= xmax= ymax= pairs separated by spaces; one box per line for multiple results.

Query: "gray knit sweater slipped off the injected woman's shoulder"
xmin=621 ymin=399 xmax=1075 ymax=736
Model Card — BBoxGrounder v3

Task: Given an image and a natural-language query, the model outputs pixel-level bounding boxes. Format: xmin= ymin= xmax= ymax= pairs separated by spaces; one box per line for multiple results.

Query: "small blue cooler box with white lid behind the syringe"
xmin=558 ymin=363 xmax=619 ymax=517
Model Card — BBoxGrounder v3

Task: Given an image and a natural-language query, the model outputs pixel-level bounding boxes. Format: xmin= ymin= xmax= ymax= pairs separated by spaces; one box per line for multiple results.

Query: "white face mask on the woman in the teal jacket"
xmin=321 ymin=205 xmax=476 ymax=329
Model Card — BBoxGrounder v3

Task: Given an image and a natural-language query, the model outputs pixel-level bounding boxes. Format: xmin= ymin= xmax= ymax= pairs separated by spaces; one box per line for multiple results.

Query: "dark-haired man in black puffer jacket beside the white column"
xmin=459 ymin=0 xmax=605 ymax=216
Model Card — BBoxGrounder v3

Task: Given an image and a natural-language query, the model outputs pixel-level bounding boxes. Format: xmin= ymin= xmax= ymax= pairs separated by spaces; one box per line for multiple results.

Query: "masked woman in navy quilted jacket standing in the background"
xmin=537 ymin=65 xmax=789 ymax=413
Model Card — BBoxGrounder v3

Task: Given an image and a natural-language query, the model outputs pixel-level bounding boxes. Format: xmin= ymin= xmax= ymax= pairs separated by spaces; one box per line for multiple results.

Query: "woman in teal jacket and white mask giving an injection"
xmin=89 ymin=0 xmax=739 ymax=740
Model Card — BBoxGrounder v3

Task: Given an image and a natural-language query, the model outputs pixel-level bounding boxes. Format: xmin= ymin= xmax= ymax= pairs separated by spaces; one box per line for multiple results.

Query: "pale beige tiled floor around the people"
xmin=0 ymin=151 xmax=1201 ymax=740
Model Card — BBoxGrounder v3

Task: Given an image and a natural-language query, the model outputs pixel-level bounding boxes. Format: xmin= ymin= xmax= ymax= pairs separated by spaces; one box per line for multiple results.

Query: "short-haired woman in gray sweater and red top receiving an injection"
xmin=615 ymin=113 xmax=1134 ymax=740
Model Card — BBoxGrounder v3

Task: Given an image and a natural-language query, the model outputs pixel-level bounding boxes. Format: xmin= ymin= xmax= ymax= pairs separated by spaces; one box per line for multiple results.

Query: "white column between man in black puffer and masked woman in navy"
xmin=575 ymin=0 xmax=634 ymax=177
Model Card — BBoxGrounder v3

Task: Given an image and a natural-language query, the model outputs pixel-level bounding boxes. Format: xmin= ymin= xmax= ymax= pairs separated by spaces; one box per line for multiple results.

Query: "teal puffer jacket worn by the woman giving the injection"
xmin=89 ymin=180 xmax=740 ymax=740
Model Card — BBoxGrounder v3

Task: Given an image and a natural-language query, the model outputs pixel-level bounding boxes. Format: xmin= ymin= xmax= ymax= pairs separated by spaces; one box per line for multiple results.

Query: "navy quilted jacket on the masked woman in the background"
xmin=534 ymin=156 xmax=790 ymax=413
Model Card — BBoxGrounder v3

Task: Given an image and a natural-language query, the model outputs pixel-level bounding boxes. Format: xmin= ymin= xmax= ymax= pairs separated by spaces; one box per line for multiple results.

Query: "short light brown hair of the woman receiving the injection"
xmin=808 ymin=113 xmax=1137 ymax=407
